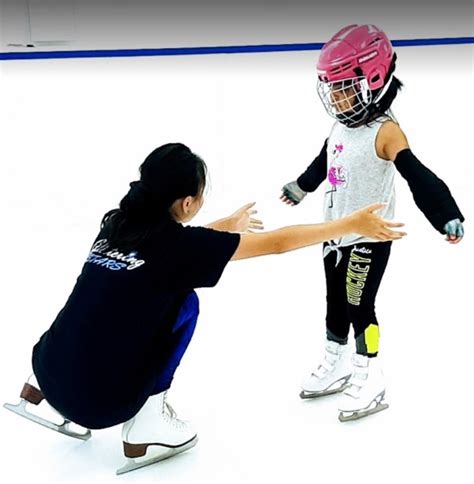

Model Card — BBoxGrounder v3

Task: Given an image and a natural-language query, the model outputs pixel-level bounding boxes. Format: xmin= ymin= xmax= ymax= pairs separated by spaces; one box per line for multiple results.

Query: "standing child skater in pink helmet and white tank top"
xmin=281 ymin=25 xmax=464 ymax=421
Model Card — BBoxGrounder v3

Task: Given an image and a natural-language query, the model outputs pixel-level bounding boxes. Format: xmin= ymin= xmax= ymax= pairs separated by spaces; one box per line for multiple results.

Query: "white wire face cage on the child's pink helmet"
xmin=317 ymin=76 xmax=372 ymax=126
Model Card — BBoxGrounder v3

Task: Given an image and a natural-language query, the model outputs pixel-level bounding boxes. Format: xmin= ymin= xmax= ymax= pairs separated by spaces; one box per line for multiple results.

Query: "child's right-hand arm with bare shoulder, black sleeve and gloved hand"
xmin=379 ymin=123 xmax=464 ymax=243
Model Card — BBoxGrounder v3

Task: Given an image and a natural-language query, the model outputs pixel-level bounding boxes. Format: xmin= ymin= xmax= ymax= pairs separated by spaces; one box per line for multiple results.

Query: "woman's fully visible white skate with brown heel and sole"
xmin=117 ymin=392 xmax=198 ymax=474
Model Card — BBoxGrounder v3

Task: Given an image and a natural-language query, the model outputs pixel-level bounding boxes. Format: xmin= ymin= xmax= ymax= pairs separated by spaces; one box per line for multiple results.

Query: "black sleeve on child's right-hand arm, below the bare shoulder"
xmin=394 ymin=148 xmax=464 ymax=234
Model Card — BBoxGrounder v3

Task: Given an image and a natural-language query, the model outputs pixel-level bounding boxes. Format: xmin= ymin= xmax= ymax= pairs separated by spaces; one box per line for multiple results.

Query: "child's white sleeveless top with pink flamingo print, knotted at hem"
xmin=324 ymin=118 xmax=396 ymax=261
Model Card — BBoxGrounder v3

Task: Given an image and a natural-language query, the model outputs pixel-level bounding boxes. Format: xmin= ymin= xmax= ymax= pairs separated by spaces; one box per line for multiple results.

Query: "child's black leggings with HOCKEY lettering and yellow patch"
xmin=324 ymin=242 xmax=392 ymax=356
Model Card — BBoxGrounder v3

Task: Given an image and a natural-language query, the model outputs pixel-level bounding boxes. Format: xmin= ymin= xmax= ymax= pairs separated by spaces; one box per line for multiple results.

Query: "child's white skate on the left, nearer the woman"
xmin=300 ymin=340 xmax=352 ymax=399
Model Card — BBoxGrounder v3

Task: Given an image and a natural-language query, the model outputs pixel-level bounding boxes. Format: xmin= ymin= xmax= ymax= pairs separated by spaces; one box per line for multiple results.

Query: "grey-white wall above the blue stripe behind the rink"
xmin=0 ymin=0 xmax=473 ymax=51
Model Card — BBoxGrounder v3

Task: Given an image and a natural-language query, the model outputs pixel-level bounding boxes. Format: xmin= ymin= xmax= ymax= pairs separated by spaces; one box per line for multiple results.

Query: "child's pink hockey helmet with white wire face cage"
xmin=316 ymin=25 xmax=394 ymax=125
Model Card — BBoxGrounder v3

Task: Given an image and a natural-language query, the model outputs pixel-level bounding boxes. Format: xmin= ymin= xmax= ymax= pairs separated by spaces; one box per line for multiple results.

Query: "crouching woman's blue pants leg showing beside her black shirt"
xmin=150 ymin=291 xmax=199 ymax=395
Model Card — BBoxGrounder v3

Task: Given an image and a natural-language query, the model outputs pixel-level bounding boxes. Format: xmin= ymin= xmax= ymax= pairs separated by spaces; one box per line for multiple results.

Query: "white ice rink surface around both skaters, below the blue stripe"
xmin=0 ymin=46 xmax=474 ymax=484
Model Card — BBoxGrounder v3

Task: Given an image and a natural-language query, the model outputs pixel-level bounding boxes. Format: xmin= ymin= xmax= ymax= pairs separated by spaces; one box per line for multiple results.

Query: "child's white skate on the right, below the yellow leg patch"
xmin=339 ymin=354 xmax=388 ymax=422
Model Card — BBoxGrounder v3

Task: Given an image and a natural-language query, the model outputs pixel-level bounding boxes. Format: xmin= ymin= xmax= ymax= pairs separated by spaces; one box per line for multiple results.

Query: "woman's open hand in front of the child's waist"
xmin=348 ymin=203 xmax=406 ymax=241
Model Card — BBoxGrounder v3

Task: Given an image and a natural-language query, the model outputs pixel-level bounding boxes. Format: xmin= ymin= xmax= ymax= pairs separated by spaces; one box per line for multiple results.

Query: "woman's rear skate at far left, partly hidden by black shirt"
xmin=3 ymin=374 xmax=92 ymax=440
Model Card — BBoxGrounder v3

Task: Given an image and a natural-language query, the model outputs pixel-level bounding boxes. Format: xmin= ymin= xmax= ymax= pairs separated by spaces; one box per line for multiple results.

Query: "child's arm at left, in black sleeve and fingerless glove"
xmin=280 ymin=139 xmax=328 ymax=205
